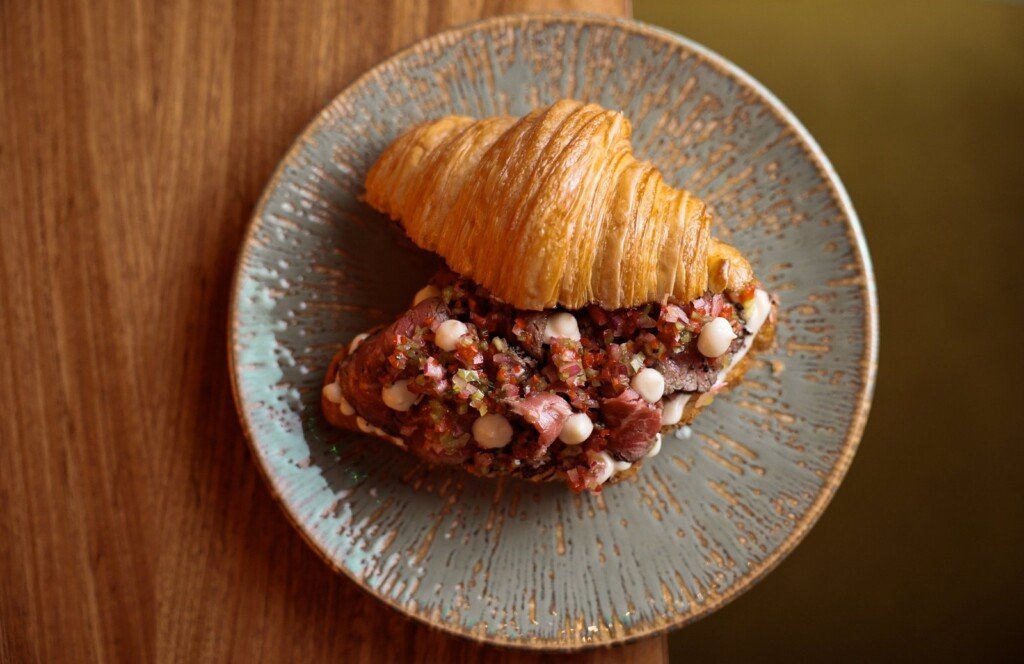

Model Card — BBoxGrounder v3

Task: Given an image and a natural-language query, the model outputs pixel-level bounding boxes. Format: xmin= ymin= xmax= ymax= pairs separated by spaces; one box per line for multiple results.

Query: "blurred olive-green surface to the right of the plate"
xmin=633 ymin=0 xmax=1024 ymax=662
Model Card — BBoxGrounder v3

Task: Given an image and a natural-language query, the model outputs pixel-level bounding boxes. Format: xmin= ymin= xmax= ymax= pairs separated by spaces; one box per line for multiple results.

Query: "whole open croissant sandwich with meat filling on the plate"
xmin=322 ymin=100 xmax=775 ymax=491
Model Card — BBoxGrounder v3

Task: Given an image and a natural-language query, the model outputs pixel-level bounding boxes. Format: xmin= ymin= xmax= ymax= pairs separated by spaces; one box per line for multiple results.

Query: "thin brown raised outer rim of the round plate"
xmin=227 ymin=12 xmax=879 ymax=652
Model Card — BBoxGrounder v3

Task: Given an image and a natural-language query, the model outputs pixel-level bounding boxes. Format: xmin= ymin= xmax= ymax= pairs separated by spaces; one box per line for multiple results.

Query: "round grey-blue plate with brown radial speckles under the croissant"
xmin=230 ymin=15 xmax=877 ymax=649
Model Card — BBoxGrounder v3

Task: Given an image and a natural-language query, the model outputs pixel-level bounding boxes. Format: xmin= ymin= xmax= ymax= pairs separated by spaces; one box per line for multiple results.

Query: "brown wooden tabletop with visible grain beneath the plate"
xmin=0 ymin=0 xmax=667 ymax=662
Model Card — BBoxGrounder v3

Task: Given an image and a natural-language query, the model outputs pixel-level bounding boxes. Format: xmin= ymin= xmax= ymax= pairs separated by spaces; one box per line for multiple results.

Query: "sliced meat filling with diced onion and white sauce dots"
xmin=323 ymin=269 xmax=772 ymax=491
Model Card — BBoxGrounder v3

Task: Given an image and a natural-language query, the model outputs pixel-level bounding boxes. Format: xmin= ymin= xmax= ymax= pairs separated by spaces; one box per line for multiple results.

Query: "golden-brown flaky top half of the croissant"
xmin=366 ymin=100 xmax=754 ymax=309
